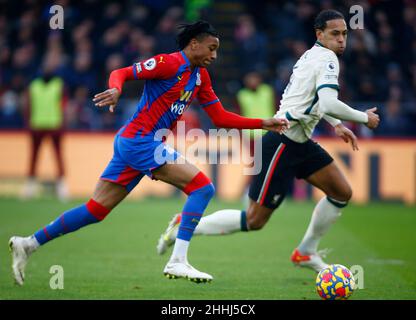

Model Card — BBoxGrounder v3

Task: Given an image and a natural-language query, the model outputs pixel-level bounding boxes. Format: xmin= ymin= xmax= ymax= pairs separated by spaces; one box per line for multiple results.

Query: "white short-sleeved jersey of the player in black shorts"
xmin=275 ymin=41 xmax=339 ymax=143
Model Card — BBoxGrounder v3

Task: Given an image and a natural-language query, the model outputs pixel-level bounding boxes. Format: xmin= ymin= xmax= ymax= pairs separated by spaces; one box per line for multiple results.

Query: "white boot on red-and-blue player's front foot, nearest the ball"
xmin=163 ymin=261 xmax=213 ymax=283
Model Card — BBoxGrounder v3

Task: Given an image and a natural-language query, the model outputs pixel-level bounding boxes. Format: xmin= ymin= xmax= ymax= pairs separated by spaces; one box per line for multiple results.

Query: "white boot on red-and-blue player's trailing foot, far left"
xmin=9 ymin=236 xmax=39 ymax=286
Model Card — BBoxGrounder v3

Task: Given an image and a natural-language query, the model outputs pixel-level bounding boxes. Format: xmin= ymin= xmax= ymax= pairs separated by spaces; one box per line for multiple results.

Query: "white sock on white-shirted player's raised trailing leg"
xmin=194 ymin=209 xmax=246 ymax=235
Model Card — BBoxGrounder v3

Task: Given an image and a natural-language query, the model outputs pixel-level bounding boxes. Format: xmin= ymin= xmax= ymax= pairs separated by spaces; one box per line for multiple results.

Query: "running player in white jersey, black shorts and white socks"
xmin=157 ymin=10 xmax=379 ymax=272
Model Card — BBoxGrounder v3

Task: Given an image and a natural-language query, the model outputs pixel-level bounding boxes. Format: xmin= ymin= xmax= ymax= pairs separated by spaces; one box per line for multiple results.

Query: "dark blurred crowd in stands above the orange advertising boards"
xmin=0 ymin=0 xmax=416 ymax=137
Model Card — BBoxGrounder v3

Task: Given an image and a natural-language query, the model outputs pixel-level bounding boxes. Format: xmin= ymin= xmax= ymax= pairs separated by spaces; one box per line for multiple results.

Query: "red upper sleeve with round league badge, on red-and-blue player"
xmin=132 ymin=54 xmax=180 ymax=80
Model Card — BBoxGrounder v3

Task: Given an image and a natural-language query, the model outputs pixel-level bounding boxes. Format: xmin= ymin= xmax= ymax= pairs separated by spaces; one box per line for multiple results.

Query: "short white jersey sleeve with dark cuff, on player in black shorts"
xmin=315 ymin=52 xmax=339 ymax=91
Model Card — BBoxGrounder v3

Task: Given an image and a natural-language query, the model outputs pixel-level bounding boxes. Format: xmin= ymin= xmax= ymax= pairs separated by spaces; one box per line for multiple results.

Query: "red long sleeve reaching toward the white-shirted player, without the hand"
xmin=204 ymin=101 xmax=263 ymax=129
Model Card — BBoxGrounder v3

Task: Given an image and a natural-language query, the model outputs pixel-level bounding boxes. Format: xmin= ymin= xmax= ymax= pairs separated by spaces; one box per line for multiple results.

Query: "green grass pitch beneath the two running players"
xmin=0 ymin=198 xmax=416 ymax=300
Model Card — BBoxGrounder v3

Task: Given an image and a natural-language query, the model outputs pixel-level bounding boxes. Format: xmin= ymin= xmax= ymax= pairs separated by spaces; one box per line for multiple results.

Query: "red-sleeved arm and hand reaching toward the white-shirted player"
xmin=204 ymin=102 xmax=289 ymax=133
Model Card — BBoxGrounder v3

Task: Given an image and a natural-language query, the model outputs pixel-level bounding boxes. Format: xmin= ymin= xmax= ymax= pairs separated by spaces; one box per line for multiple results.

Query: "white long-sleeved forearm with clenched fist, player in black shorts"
xmin=318 ymin=88 xmax=380 ymax=129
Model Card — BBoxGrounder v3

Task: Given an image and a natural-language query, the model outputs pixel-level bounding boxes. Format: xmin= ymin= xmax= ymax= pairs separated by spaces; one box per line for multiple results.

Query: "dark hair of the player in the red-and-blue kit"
xmin=176 ymin=20 xmax=220 ymax=50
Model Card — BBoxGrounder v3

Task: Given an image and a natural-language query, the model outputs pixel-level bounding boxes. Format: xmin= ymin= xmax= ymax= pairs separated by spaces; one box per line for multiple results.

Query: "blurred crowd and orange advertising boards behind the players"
xmin=0 ymin=0 xmax=416 ymax=203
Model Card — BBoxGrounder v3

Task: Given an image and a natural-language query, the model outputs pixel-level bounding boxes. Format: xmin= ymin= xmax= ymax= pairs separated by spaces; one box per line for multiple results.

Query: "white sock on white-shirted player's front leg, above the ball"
xmin=298 ymin=196 xmax=347 ymax=254
